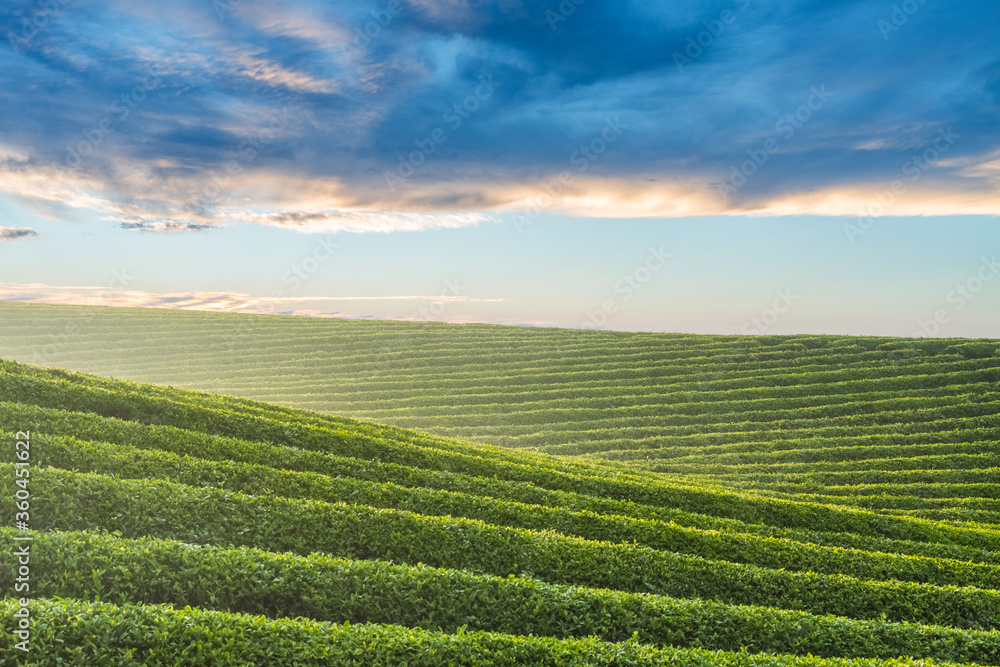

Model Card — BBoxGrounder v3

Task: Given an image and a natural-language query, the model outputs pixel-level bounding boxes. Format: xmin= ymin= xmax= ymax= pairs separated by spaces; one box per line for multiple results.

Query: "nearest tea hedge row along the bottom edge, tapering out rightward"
xmin=0 ymin=598 xmax=988 ymax=667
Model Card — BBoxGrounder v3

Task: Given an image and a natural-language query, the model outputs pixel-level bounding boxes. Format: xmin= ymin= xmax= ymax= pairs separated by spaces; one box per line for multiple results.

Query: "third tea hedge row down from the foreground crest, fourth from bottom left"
xmin=32 ymin=435 xmax=1000 ymax=590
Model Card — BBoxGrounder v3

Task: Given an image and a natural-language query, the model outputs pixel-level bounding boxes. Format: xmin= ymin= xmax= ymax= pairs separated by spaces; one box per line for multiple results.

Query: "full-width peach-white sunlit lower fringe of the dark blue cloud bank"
xmin=0 ymin=136 xmax=1000 ymax=234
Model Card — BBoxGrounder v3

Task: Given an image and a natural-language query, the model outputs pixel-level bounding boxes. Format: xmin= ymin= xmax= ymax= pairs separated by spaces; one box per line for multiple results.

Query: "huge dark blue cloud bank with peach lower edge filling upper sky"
xmin=0 ymin=0 xmax=1000 ymax=227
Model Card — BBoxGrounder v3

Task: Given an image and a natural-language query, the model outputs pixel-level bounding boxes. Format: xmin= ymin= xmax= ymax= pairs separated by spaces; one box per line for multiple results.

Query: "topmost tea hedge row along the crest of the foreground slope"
xmin=0 ymin=372 xmax=1000 ymax=550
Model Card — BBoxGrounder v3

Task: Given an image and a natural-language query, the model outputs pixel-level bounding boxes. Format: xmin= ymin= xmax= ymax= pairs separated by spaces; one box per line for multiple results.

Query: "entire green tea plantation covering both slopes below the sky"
xmin=0 ymin=304 xmax=1000 ymax=667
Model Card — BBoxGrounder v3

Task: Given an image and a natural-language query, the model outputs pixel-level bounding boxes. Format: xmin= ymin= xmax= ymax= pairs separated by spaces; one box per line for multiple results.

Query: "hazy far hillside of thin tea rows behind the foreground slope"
xmin=0 ymin=303 xmax=1000 ymax=480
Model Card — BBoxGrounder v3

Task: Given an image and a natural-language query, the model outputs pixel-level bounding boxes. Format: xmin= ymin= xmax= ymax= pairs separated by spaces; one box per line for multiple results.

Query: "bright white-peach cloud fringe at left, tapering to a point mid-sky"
xmin=0 ymin=145 xmax=494 ymax=233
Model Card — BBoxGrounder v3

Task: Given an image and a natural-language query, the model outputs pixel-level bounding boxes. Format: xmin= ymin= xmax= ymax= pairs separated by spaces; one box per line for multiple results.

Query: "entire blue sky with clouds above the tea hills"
xmin=0 ymin=0 xmax=1000 ymax=337
